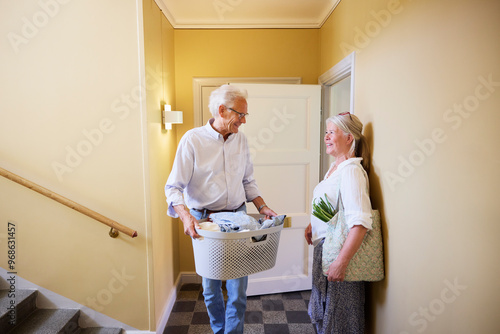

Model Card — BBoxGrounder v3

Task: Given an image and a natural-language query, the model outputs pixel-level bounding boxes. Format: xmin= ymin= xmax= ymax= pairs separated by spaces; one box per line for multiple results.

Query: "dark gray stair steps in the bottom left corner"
xmin=0 ymin=289 xmax=122 ymax=334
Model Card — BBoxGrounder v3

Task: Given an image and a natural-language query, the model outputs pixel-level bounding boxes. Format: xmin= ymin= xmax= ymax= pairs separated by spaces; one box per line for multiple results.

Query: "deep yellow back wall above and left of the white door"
xmin=174 ymin=29 xmax=319 ymax=271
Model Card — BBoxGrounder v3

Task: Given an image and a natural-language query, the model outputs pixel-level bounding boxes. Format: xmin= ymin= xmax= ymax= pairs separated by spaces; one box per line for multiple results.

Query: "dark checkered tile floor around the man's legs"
xmin=163 ymin=284 xmax=316 ymax=334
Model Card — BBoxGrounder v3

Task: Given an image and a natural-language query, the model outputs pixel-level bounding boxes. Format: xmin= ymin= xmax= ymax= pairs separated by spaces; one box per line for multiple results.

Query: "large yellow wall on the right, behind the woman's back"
xmin=321 ymin=0 xmax=500 ymax=333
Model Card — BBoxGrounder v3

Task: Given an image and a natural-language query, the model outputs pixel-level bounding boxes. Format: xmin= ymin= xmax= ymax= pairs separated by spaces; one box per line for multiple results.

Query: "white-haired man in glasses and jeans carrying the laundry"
xmin=165 ymin=85 xmax=276 ymax=334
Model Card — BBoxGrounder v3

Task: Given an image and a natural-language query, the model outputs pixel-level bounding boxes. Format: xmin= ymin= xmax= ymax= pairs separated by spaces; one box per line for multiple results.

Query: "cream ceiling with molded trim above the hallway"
xmin=155 ymin=0 xmax=340 ymax=29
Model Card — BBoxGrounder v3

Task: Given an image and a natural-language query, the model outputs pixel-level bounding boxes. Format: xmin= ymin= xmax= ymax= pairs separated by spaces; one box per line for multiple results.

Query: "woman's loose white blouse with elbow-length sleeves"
xmin=311 ymin=158 xmax=372 ymax=246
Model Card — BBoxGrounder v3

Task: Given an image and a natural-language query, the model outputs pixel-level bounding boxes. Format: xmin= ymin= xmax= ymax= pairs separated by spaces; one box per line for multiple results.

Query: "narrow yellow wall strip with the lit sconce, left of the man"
xmin=143 ymin=0 xmax=179 ymax=325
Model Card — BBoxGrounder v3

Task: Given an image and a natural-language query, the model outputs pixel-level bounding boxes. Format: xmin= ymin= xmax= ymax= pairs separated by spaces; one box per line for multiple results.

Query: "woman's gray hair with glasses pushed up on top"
xmin=326 ymin=113 xmax=370 ymax=173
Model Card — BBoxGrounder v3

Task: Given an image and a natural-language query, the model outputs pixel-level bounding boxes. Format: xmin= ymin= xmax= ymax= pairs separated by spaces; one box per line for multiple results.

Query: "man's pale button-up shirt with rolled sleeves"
xmin=165 ymin=118 xmax=261 ymax=218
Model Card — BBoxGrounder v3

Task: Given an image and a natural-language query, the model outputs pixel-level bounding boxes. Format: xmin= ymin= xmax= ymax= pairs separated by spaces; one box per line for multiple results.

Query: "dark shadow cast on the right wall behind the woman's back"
xmin=364 ymin=123 xmax=389 ymax=333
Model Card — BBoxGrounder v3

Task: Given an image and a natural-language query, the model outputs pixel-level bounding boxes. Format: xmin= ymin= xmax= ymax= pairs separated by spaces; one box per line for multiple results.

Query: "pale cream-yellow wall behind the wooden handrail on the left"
xmin=0 ymin=0 xmax=153 ymax=329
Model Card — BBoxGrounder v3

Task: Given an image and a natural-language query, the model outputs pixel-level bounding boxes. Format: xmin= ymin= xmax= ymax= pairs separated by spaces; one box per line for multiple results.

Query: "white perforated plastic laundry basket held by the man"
xmin=192 ymin=215 xmax=283 ymax=280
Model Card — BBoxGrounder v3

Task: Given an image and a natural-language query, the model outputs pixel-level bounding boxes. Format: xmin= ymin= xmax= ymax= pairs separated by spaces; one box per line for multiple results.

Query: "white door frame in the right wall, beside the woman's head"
xmin=318 ymin=52 xmax=356 ymax=180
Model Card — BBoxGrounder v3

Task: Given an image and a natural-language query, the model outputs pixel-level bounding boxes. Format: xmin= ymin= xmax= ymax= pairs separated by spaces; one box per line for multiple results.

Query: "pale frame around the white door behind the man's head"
xmin=193 ymin=77 xmax=302 ymax=127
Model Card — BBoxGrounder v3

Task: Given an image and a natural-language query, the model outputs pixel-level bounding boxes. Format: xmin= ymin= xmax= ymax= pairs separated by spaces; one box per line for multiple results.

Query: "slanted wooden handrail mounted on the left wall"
xmin=0 ymin=167 xmax=137 ymax=238
